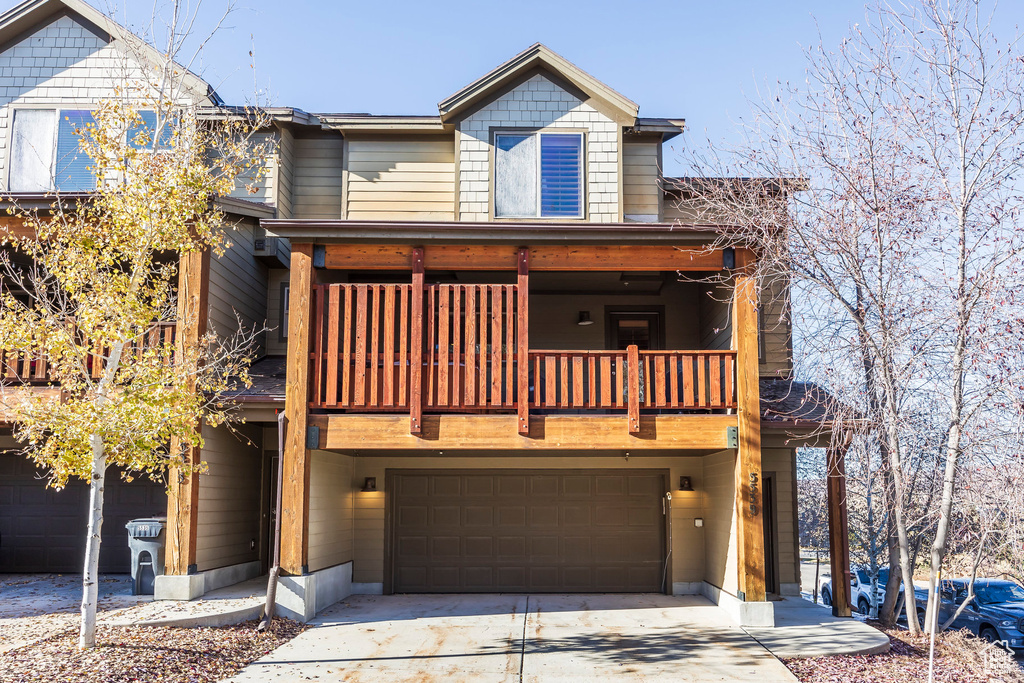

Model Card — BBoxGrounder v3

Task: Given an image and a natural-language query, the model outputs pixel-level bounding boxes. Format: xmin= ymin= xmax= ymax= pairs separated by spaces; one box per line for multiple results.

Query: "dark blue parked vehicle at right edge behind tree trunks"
xmin=914 ymin=579 xmax=1024 ymax=651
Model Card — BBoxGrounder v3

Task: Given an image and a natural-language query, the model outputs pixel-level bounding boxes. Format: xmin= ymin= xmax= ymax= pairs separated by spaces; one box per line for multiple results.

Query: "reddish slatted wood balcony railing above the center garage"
xmin=309 ymin=284 xmax=736 ymax=430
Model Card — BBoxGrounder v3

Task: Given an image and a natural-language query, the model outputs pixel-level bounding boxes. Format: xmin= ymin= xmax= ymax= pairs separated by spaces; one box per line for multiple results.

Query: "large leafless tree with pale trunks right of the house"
xmin=681 ymin=0 xmax=1024 ymax=632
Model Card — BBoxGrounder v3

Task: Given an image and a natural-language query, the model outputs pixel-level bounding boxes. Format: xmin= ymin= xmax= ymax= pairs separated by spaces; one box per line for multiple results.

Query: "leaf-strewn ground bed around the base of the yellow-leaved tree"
xmin=0 ymin=620 xmax=305 ymax=683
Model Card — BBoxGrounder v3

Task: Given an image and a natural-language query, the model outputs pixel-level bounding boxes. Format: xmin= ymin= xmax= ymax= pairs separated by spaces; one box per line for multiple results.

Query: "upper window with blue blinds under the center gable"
xmin=495 ymin=132 xmax=583 ymax=218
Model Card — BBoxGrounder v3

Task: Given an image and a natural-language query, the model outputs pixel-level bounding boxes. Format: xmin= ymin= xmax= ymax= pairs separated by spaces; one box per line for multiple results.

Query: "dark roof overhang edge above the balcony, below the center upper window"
xmin=260 ymin=219 xmax=723 ymax=246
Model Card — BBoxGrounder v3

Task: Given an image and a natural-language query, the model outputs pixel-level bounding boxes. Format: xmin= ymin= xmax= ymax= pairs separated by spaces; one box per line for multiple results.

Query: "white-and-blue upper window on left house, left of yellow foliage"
xmin=8 ymin=110 xmax=96 ymax=193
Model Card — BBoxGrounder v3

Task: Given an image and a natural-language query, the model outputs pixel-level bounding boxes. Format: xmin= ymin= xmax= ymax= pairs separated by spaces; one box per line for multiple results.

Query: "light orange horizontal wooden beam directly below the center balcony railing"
xmin=309 ymin=415 xmax=736 ymax=452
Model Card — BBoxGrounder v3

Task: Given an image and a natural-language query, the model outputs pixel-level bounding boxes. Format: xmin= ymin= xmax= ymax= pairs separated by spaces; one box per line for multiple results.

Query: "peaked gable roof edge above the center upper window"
xmin=437 ymin=43 xmax=640 ymax=125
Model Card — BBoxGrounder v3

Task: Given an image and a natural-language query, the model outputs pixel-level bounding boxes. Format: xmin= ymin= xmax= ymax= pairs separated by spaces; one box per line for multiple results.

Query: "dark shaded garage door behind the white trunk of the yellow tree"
xmin=0 ymin=455 xmax=167 ymax=573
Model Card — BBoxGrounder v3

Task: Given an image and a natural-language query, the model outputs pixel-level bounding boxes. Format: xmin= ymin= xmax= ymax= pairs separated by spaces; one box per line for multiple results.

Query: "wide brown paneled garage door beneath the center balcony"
xmin=386 ymin=470 xmax=666 ymax=593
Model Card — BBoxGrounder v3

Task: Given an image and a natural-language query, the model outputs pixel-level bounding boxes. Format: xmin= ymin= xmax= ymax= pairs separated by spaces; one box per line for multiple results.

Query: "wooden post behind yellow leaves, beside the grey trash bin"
xmin=164 ymin=250 xmax=210 ymax=574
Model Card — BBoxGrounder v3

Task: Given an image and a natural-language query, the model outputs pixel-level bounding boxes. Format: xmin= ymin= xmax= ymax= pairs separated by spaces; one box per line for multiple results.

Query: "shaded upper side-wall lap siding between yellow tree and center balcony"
xmin=210 ymin=221 xmax=267 ymax=356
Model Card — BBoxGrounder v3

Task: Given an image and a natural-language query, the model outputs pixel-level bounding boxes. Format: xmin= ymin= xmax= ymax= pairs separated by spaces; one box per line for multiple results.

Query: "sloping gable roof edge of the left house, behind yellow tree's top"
xmin=0 ymin=0 xmax=223 ymax=105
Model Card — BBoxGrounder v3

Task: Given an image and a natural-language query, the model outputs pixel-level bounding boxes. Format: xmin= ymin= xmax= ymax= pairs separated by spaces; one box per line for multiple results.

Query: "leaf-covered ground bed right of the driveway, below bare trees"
xmin=783 ymin=624 xmax=1024 ymax=683
